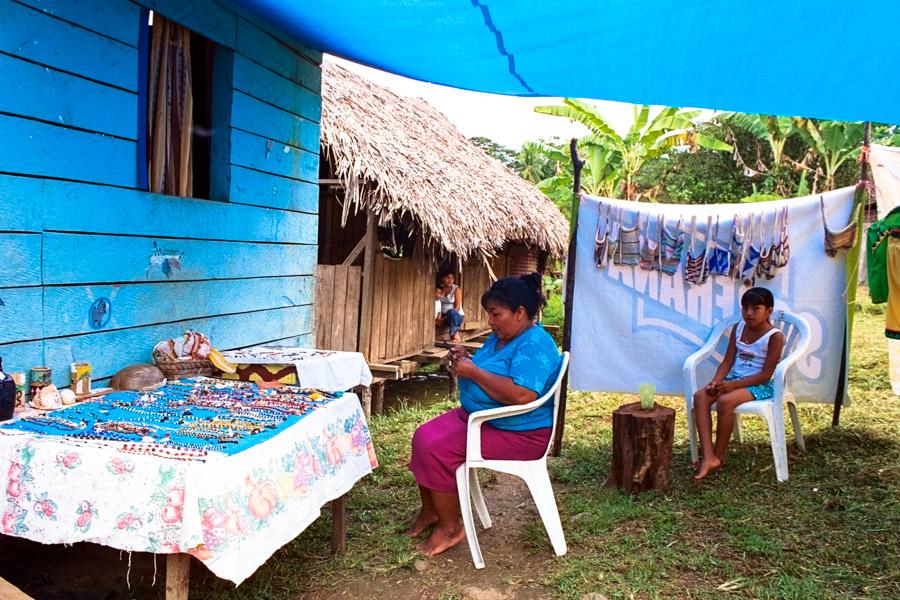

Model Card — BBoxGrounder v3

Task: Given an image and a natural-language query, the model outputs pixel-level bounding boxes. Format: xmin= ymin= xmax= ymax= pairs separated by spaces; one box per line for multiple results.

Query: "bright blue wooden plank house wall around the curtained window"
xmin=0 ymin=0 xmax=321 ymax=385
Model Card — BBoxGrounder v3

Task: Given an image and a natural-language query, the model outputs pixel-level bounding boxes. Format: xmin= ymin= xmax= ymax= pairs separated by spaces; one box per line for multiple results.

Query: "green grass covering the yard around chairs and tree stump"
xmin=191 ymin=296 xmax=900 ymax=600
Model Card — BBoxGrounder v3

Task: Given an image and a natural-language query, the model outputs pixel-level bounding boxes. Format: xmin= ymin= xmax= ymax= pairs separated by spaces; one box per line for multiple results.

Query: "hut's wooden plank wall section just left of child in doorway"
xmin=366 ymin=253 xmax=435 ymax=362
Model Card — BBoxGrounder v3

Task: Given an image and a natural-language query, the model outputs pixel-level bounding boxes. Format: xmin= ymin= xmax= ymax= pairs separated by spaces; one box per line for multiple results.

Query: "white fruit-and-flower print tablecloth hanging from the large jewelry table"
xmin=0 ymin=393 xmax=378 ymax=584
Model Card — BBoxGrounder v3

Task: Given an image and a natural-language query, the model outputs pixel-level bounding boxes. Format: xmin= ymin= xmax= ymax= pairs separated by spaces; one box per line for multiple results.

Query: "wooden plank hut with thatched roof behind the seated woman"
xmin=316 ymin=62 xmax=568 ymax=377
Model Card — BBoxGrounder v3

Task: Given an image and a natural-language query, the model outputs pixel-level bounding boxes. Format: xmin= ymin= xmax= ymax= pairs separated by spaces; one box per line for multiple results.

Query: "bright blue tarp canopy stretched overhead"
xmin=236 ymin=0 xmax=900 ymax=123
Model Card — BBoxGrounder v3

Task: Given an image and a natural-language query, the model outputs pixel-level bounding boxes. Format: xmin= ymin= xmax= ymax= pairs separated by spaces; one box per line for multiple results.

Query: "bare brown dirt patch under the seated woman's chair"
xmin=306 ymin=474 xmax=554 ymax=600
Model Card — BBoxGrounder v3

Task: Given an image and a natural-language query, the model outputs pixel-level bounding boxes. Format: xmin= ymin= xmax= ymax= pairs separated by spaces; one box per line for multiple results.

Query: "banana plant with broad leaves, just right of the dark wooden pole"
xmin=534 ymin=98 xmax=732 ymax=200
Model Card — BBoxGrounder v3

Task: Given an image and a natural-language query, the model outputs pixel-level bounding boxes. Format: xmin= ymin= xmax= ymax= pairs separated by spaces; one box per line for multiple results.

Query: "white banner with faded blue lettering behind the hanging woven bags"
xmin=570 ymin=188 xmax=854 ymax=403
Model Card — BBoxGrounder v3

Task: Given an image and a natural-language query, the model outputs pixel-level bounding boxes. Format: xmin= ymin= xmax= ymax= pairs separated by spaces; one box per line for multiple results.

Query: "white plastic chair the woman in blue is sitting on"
xmin=456 ymin=352 xmax=569 ymax=569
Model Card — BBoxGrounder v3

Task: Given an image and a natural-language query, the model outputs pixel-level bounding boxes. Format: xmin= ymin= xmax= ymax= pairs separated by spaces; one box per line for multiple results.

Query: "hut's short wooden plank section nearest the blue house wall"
xmin=316 ymin=265 xmax=362 ymax=352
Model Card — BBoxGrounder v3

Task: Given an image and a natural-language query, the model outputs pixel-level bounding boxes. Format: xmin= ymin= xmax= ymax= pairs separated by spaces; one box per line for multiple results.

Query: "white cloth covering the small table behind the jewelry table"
xmin=222 ymin=346 xmax=372 ymax=392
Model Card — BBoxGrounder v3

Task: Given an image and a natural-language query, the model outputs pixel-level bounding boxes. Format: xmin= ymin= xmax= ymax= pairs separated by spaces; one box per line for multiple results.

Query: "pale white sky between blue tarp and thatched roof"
xmin=325 ymin=56 xmax=633 ymax=150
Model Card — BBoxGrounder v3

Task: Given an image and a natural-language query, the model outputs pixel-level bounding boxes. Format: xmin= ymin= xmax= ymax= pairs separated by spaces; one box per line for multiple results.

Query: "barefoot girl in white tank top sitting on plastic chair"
xmin=694 ymin=287 xmax=784 ymax=480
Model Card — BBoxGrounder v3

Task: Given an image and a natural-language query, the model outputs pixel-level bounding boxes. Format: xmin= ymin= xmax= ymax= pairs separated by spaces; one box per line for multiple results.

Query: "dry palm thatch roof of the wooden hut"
xmin=321 ymin=61 xmax=568 ymax=259
